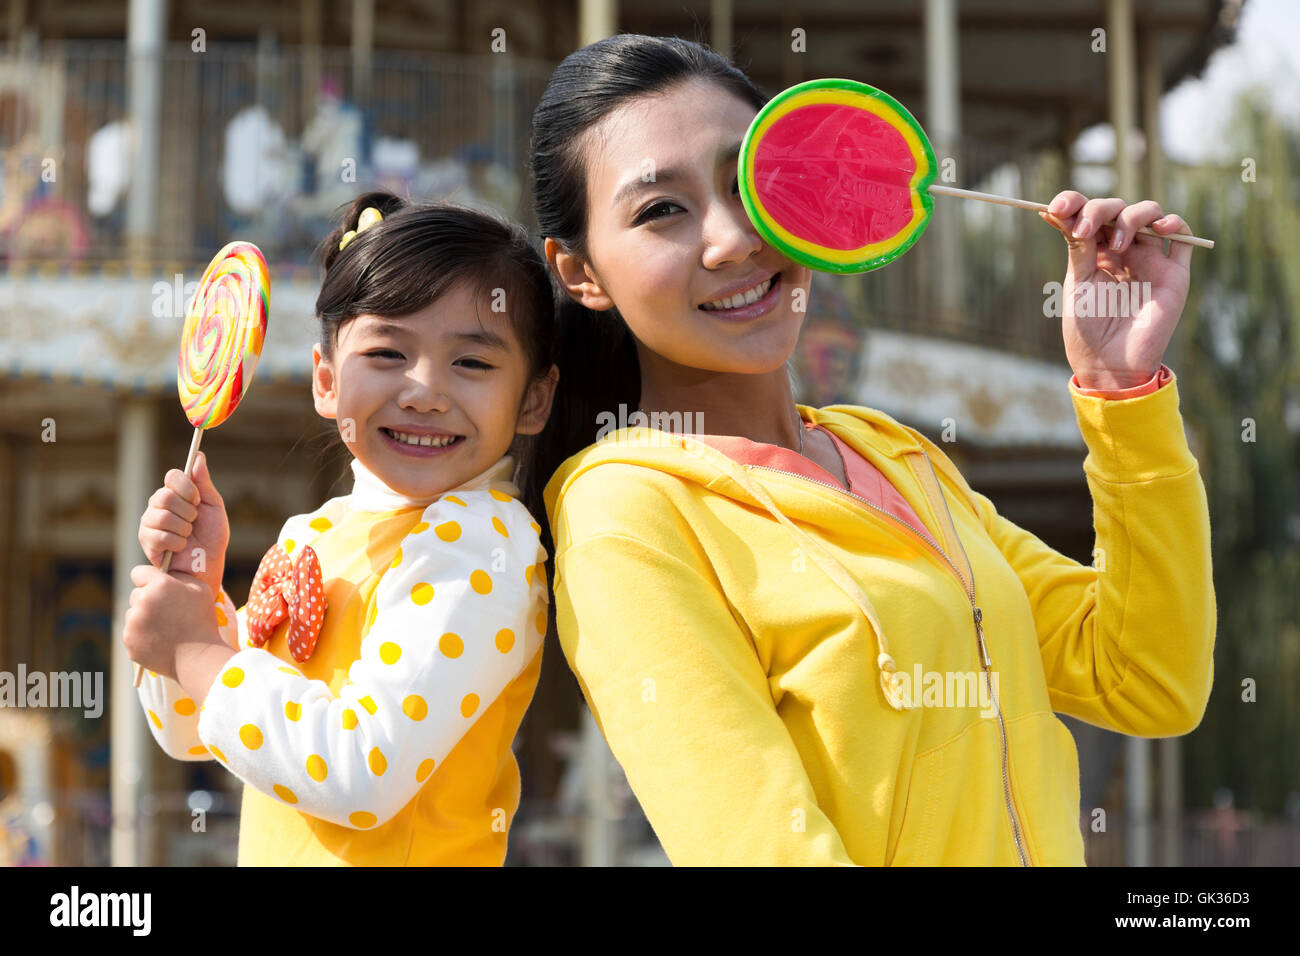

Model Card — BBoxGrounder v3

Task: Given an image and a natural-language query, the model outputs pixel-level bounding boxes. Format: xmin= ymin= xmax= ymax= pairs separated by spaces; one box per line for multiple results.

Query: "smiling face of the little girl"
xmin=312 ymin=282 xmax=558 ymax=498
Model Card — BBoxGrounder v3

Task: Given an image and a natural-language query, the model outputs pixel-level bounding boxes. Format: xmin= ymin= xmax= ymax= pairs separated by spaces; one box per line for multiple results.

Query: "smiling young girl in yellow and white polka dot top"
xmin=124 ymin=194 xmax=556 ymax=865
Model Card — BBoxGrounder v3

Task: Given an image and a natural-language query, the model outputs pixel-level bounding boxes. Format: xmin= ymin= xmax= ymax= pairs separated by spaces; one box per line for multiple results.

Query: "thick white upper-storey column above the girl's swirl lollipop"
xmin=126 ymin=0 xmax=166 ymax=254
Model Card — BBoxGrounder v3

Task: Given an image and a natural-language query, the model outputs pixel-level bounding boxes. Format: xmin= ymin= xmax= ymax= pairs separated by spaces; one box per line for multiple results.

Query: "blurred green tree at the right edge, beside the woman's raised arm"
xmin=1170 ymin=94 xmax=1300 ymax=813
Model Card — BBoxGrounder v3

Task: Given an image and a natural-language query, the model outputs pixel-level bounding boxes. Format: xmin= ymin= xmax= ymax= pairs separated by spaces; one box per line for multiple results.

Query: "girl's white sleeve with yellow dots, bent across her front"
xmin=198 ymin=490 xmax=546 ymax=830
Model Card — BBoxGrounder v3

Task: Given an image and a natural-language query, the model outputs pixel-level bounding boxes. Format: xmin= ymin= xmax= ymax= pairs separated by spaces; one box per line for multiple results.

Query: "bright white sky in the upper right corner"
xmin=1075 ymin=0 xmax=1300 ymax=163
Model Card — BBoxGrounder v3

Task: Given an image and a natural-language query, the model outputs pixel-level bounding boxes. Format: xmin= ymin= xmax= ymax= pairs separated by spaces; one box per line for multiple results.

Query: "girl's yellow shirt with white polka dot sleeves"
xmin=139 ymin=455 xmax=547 ymax=866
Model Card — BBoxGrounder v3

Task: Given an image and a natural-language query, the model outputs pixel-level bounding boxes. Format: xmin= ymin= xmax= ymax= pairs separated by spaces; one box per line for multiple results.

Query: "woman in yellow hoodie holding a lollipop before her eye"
xmin=532 ymin=35 xmax=1216 ymax=865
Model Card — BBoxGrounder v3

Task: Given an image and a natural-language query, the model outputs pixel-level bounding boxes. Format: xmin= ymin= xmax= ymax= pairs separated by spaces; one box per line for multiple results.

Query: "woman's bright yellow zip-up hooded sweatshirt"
xmin=546 ymin=380 xmax=1217 ymax=865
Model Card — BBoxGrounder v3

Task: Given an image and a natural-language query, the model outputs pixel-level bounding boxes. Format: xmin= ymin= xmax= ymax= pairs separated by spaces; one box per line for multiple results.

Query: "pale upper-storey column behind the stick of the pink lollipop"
xmin=924 ymin=0 xmax=972 ymax=330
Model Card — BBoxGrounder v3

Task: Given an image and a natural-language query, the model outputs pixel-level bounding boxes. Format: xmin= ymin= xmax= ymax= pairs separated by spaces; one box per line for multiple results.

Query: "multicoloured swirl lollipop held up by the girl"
xmin=135 ymin=242 xmax=270 ymax=687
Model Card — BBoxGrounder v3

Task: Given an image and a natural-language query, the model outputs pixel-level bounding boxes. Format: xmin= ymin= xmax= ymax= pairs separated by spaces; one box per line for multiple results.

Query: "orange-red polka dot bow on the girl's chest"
xmin=247 ymin=544 xmax=325 ymax=663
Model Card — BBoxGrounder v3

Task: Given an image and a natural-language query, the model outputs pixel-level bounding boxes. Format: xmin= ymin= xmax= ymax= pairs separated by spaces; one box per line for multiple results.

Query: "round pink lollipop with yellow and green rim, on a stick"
xmin=740 ymin=79 xmax=1214 ymax=274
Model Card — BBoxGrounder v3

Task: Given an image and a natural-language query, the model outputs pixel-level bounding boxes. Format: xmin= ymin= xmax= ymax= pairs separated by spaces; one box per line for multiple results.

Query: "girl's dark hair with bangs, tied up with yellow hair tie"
xmin=316 ymin=193 xmax=556 ymax=515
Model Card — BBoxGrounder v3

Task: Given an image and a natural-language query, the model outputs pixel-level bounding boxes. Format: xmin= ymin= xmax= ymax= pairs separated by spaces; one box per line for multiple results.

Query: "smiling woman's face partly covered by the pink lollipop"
xmin=547 ymin=81 xmax=811 ymax=375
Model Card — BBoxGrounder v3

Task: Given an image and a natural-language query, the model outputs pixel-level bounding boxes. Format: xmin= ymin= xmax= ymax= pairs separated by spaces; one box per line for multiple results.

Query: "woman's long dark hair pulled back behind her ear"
xmin=530 ymin=34 xmax=767 ymax=538
